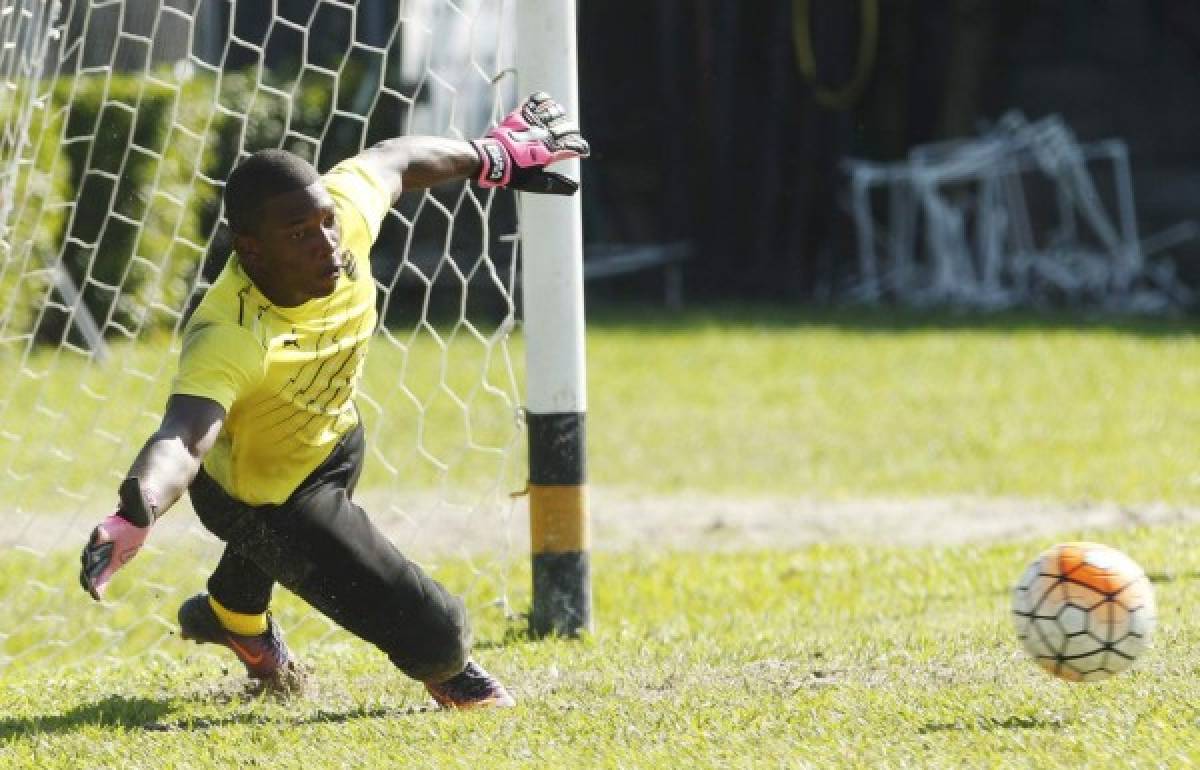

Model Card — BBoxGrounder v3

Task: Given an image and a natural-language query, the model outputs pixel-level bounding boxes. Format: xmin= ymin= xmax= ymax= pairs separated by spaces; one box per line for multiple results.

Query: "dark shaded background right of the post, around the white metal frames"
xmin=580 ymin=0 xmax=1200 ymax=309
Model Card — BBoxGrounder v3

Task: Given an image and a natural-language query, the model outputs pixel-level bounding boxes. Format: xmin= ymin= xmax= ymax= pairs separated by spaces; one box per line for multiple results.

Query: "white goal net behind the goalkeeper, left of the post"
xmin=0 ymin=0 xmax=526 ymax=668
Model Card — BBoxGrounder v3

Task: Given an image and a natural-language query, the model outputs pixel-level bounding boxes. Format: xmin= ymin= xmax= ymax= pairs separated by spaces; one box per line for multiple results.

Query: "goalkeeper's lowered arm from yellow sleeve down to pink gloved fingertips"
xmin=79 ymin=395 xmax=226 ymax=601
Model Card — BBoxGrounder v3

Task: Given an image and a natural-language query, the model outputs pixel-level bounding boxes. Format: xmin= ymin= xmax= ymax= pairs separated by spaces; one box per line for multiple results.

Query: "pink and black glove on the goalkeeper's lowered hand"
xmin=79 ymin=479 xmax=155 ymax=602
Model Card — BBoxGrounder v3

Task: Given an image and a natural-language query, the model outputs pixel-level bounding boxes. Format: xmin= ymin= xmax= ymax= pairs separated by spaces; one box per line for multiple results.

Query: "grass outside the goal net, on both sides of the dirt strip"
xmin=0 ymin=302 xmax=1200 ymax=768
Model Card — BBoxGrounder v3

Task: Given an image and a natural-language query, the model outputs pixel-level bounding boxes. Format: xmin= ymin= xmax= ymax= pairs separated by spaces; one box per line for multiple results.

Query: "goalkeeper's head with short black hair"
xmin=224 ymin=150 xmax=342 ymax=307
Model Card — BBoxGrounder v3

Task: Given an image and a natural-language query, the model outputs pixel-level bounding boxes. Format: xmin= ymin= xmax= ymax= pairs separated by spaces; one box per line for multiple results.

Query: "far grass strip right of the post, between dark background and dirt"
xmin=588 ymin=309 xmax=1200 ymax=504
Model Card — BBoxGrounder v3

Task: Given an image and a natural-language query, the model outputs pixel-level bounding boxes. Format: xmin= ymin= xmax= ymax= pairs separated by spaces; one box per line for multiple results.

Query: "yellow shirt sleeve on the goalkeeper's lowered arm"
xmin=172 ymin=321 xmax=264 ymax=411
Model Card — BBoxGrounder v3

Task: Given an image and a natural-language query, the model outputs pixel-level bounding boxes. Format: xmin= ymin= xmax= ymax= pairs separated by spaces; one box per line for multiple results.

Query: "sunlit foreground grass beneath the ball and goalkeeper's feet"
xmin=0 ymin=527 xmax=1200 ymax=769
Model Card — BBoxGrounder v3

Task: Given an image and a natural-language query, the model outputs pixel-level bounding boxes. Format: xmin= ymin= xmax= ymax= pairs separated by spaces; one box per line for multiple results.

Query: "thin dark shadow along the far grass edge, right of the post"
xmin=588 ymin=302 xmax=1200 ymax=337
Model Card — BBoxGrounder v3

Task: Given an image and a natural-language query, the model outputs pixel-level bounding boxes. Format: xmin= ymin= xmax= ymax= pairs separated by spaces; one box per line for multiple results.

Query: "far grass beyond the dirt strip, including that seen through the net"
xmin=0 ymin=307 xmax=1200 ymax=511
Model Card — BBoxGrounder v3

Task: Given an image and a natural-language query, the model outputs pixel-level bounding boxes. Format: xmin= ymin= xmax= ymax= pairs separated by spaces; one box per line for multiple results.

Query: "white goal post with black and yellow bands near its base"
xmin=516 ymin=0 xmax=592 ymax=636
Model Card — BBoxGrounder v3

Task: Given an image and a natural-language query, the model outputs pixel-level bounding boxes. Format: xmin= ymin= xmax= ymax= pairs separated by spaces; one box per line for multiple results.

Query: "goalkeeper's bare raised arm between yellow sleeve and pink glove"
xmin=360 ymin=137 xmax=480 ymax=199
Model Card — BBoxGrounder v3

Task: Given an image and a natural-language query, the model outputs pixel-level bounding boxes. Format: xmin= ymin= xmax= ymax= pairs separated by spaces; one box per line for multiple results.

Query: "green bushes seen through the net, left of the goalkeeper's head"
xmin=0 ymin=65 xmax=356 ymax=345
